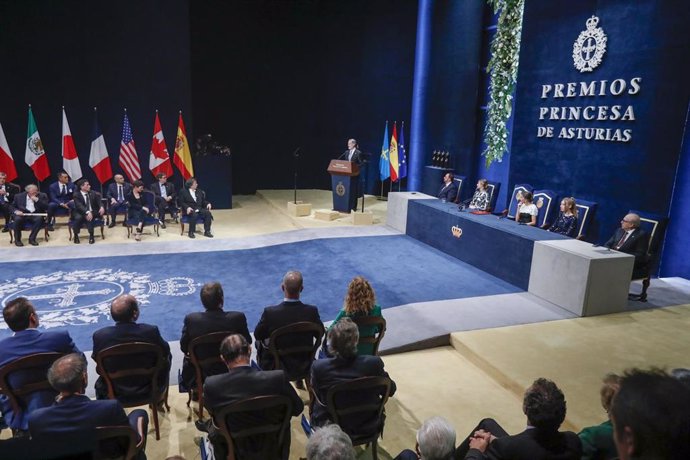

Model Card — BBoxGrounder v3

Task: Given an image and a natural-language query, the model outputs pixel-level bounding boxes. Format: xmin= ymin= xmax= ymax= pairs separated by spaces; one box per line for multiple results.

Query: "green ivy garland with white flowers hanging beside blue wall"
xmin=482 ymin=0 xmax=525 ymax=168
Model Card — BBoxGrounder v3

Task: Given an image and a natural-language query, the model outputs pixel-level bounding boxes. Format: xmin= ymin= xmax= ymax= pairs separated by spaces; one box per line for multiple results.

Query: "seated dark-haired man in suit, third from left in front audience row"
xmin=180 ymin=282 xmax=252 ymax=388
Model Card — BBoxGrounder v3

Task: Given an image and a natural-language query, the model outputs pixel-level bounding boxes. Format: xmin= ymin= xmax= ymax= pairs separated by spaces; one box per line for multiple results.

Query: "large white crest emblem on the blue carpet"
xmin=0 ymin=268 xmax=200 ymax=329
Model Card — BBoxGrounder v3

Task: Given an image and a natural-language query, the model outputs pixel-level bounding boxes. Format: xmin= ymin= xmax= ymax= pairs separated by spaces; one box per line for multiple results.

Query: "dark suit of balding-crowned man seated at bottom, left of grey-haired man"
xmin=204 ymin=366 xmax=304 ymax=459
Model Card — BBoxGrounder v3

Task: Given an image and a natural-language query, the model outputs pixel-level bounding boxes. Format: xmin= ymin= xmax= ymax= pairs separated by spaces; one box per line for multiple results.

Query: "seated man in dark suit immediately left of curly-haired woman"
xmin=254 ymin=271 xmax=323 ymax=369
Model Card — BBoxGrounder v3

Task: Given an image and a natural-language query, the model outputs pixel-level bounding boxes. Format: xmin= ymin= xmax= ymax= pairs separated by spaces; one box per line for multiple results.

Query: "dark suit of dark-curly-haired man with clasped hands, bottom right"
xmin=455 ymin=419 xmax=582 ymax=460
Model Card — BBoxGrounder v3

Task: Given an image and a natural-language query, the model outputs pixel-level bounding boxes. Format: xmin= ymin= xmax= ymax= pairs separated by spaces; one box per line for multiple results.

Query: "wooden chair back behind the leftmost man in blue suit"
xmin=0 ymin=353 xmax=65 ymax=414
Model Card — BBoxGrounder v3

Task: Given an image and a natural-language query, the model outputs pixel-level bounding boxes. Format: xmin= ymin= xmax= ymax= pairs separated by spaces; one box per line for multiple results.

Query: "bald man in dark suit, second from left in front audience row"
xmin=91 ymin=294 xmax=171 ymax=402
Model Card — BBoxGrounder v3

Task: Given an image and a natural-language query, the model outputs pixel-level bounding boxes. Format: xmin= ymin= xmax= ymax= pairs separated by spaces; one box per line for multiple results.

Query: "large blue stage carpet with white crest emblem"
xmin=0 ymin=235 xmax=520 ymax=350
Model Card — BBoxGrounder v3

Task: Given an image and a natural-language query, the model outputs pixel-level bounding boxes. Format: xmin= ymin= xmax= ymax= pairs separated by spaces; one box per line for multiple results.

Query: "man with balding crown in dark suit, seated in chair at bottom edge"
xmin=204 ymin=334 xmax=304 ymax=460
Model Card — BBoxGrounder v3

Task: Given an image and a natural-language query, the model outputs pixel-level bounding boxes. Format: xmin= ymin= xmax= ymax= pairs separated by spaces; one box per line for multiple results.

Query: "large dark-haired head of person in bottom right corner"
xmin=611 ymin=369 xmax=690 ymax=460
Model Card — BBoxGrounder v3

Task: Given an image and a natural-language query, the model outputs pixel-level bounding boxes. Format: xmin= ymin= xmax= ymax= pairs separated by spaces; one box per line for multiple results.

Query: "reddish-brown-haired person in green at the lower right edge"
xmin=578 ymin=374 xmax=621 ymax=460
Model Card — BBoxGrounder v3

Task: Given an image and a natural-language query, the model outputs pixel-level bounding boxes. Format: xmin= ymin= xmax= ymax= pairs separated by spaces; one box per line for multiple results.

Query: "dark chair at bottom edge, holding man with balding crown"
xmin=213 ymin=395 xmax=292 ymax=460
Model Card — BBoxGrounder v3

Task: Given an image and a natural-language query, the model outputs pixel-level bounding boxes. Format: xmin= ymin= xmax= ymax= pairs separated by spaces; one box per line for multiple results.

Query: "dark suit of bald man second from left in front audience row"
xmin=91 ymin=322 xmax=171 ymax=402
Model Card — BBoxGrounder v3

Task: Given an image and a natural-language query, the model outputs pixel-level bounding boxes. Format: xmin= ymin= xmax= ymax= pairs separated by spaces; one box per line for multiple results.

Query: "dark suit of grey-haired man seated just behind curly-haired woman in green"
xmin=311 ymin=355 xmax=396 ymax=434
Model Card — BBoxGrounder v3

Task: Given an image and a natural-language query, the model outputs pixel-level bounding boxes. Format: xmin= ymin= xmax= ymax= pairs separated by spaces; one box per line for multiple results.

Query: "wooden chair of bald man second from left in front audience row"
xmin=95 ymin=342 xmax=170 ymax=440
